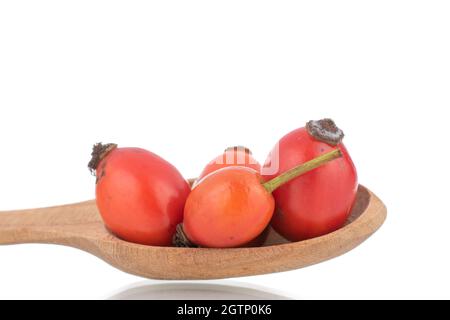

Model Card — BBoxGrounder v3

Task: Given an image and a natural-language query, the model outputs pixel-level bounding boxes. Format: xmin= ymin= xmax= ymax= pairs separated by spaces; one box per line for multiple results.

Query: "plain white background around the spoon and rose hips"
xmin=0 ymin=0 xmax=450 ymax=299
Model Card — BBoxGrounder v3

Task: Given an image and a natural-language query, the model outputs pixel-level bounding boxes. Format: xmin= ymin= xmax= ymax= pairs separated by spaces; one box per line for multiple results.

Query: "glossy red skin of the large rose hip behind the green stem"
xmin=264 ymin=128 xmax=358 ymax=241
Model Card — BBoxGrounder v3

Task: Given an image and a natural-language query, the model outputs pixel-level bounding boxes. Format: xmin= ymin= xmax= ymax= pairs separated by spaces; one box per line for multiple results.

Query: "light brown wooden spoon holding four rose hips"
xmin=0 ymin=186 xmax=386 ymax=280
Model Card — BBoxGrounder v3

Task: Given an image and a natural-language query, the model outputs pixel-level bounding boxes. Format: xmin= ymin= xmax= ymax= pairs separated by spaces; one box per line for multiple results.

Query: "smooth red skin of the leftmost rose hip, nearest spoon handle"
xmin=96 ymin=148 xmax=190 ymax=246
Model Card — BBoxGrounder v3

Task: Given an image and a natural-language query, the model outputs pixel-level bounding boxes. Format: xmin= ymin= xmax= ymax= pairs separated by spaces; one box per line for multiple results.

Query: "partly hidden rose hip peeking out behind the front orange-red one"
xmin=197 ymin=147 xmax=261 ymax=181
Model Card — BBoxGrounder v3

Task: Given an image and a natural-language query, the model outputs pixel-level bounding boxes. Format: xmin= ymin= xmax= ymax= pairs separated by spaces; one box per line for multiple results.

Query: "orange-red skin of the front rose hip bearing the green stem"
xmin=183 ymin=167 xmax=275 ymax=248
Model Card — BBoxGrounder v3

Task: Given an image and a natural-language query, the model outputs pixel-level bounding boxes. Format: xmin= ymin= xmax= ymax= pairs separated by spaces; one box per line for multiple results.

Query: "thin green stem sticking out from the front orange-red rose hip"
xmin=263 ymin=149 xmax=342 ymax=193
